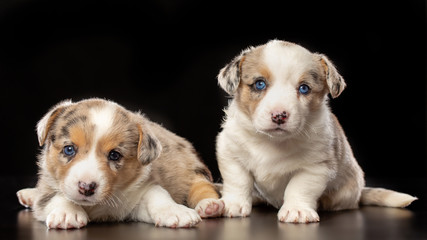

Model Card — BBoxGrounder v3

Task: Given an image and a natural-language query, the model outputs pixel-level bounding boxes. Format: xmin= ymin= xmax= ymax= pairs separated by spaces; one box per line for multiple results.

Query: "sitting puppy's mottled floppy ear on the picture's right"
xmin=318 ymin=54 xmax=346 ymax=98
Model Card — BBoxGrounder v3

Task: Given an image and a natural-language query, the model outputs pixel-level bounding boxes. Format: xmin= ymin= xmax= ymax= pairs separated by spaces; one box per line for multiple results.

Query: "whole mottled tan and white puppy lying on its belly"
xmin=17 ymin=99 xmax=223 ymax=229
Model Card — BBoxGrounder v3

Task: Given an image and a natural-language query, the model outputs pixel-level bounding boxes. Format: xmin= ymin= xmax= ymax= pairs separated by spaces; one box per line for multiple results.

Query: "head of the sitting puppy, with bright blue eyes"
xmin=218 ymin=40 xmax=345 ymax=138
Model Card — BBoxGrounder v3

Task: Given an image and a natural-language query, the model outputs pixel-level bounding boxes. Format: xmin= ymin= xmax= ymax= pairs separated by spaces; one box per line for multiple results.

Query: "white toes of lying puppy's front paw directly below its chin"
xmin=46 ymin=208 xmax=89 ymax=229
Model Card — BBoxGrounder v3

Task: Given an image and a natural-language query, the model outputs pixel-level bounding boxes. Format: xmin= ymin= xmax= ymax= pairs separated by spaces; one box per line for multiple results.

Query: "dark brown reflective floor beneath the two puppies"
xmin=0 ymin=176 xmax=427 ymax=240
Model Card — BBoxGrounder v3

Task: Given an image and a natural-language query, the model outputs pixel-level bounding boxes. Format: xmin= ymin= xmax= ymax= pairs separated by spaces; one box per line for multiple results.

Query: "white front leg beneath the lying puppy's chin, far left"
xmin=42 ymin=195 xmax=89 ymax=229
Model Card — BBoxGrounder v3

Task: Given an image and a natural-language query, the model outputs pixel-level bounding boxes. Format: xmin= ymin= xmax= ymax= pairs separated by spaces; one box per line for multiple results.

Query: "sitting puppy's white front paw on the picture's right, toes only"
xmin=277 ymin=205 xmax=320 ymax=223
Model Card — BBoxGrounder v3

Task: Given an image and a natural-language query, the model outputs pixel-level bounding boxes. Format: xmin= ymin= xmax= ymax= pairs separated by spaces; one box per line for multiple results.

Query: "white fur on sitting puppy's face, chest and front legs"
xmin=217 ymin=41 xmax=358 ymax=222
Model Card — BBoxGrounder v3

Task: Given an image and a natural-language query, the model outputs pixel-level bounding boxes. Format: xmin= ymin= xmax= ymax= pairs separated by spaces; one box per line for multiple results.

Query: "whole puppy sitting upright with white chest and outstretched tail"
xmin=217 ymin=40 xmax=416 ymax=223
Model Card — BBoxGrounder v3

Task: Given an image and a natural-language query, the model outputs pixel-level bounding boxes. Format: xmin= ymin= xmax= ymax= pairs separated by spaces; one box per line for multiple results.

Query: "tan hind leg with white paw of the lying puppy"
xmin=187 ymin=176 xmax=224 ymax=218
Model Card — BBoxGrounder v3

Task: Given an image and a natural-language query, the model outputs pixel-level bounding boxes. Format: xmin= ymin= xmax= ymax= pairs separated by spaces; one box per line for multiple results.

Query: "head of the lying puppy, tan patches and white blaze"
xmin=37 ymin=99 xmax=161 ymax=206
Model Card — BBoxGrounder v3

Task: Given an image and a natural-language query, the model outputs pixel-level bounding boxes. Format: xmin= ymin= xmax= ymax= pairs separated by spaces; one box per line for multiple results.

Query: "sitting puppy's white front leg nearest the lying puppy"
xmin=218 ymin=157 xmax=254 ymax=217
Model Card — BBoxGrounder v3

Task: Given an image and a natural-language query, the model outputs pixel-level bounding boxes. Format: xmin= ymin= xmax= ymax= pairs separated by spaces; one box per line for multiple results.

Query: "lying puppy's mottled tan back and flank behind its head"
xmin=150 ymin=122 xmax=219 ymax=208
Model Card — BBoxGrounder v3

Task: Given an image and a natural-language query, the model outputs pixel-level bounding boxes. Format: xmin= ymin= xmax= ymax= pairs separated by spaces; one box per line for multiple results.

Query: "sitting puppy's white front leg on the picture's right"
xmin=278 ymin=171 xmax=328 ymax=223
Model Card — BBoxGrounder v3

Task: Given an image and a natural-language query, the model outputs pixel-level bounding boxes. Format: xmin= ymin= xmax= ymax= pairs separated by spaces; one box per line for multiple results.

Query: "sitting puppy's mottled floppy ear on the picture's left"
xmin=218 ymin=48 xmax=252 ymax=96
